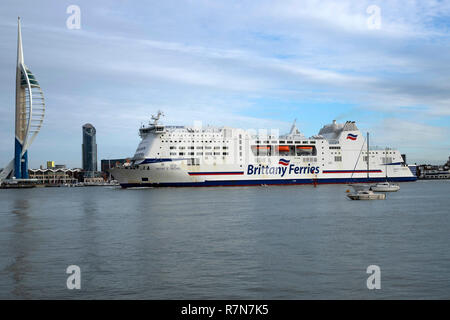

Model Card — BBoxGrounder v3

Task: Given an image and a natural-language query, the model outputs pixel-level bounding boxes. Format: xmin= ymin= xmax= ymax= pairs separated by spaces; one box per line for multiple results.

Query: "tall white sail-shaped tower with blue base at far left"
xmin=0 ymin=18 xmax=45 ymax=181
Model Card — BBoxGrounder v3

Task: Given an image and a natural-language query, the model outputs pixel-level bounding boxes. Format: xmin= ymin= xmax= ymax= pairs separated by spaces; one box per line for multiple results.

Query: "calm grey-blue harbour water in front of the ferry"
xmin=0 ymin=181 xmax=450 ymax=299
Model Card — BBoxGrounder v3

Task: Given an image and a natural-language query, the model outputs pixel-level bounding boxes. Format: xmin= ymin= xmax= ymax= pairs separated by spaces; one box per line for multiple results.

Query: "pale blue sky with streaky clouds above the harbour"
xmin=0 ymin=0 xmax=450 ymax=168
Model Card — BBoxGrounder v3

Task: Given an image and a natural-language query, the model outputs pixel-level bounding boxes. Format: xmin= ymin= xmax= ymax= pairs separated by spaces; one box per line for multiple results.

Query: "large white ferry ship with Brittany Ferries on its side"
xmin=110 ymin=112 xmax=417 ymax=188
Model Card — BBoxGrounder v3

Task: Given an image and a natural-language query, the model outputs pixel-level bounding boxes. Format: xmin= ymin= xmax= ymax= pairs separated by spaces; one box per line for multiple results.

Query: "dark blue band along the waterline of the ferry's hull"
xmin=120 ymin=177 xmax=417 ymax=188
